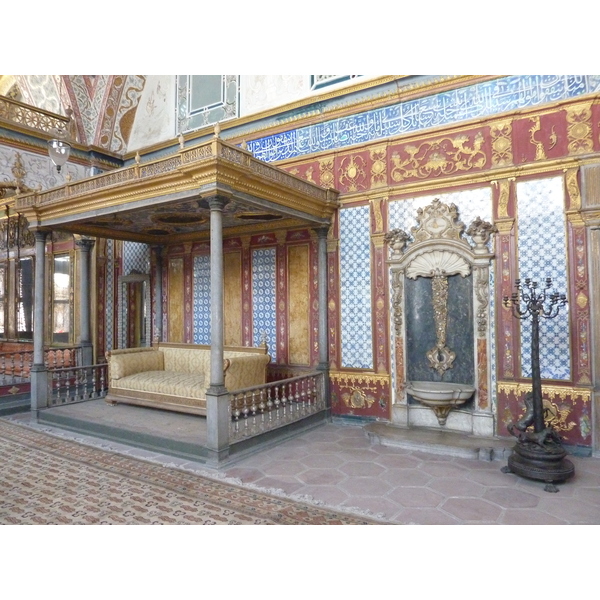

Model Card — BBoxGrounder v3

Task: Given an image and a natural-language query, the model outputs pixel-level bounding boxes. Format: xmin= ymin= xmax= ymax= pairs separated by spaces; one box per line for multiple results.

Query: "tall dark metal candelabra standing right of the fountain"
xmin=502 ymin=277 xmax=575 ymax=492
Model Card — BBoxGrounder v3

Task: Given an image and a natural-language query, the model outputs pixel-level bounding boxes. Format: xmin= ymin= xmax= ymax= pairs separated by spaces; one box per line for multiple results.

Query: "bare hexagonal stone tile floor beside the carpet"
xmin=8 ymin=417 xmax=600 ymax=525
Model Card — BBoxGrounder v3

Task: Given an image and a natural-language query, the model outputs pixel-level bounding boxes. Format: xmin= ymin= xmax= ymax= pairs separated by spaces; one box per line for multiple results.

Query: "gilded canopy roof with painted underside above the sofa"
xmin=16 ymin=137 xmax=338 ymax=245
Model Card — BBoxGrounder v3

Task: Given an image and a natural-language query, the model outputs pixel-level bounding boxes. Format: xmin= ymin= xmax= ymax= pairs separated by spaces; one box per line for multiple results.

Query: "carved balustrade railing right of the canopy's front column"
xmin=229 ymin=371 xmax=326 ymax=443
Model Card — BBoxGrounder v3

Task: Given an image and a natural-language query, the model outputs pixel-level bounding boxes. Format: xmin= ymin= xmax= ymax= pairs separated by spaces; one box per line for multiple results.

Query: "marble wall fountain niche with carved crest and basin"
xmin=385 ymin=198 xmax=497 ymax=437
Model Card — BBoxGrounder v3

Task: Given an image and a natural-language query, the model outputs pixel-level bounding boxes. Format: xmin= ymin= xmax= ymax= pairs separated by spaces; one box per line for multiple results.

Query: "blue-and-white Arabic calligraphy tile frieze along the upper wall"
xmin=248 ymin=75 xmax=600 ymax=162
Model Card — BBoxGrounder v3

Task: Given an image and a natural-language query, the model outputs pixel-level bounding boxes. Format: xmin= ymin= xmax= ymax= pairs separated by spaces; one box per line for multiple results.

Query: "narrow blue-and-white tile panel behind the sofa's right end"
xmin=252 ymin=248 xmax=277 ymax=362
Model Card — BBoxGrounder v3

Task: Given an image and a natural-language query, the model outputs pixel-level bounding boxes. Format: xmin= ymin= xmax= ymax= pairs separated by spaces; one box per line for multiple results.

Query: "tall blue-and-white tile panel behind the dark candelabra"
xmin=517 ymin=177 xmax=571 ymax=380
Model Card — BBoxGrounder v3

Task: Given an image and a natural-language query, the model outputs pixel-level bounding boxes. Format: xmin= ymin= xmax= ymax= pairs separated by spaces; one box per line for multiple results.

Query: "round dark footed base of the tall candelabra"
xmin=502 ymin=441 xmax=575 ymax=492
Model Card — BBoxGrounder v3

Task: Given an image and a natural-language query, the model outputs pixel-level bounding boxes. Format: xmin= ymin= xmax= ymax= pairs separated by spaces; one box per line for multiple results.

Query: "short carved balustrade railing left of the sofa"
xmin=48 ymin=363 xmax=108 ymax=406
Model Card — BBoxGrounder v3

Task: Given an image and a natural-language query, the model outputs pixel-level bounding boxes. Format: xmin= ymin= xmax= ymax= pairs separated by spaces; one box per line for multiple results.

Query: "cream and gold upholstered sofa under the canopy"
xmin=106 ymin=343 xmax=271 ymax=415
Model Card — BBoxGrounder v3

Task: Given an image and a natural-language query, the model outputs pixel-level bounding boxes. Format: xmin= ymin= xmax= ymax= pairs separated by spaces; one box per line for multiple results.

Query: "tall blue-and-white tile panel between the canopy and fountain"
xmin=340 ymin=206 xmax=373 ymax=369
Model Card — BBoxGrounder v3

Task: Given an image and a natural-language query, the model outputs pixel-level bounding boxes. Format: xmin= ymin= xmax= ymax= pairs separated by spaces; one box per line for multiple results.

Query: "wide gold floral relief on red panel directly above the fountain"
xmin=391 ymin=132 xmax=487 ymax=182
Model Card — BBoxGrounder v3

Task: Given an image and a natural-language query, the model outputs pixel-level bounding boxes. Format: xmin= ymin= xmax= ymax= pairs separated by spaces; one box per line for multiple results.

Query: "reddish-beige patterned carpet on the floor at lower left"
xmin=0 ymin=419 xmax=380 ymax=525
